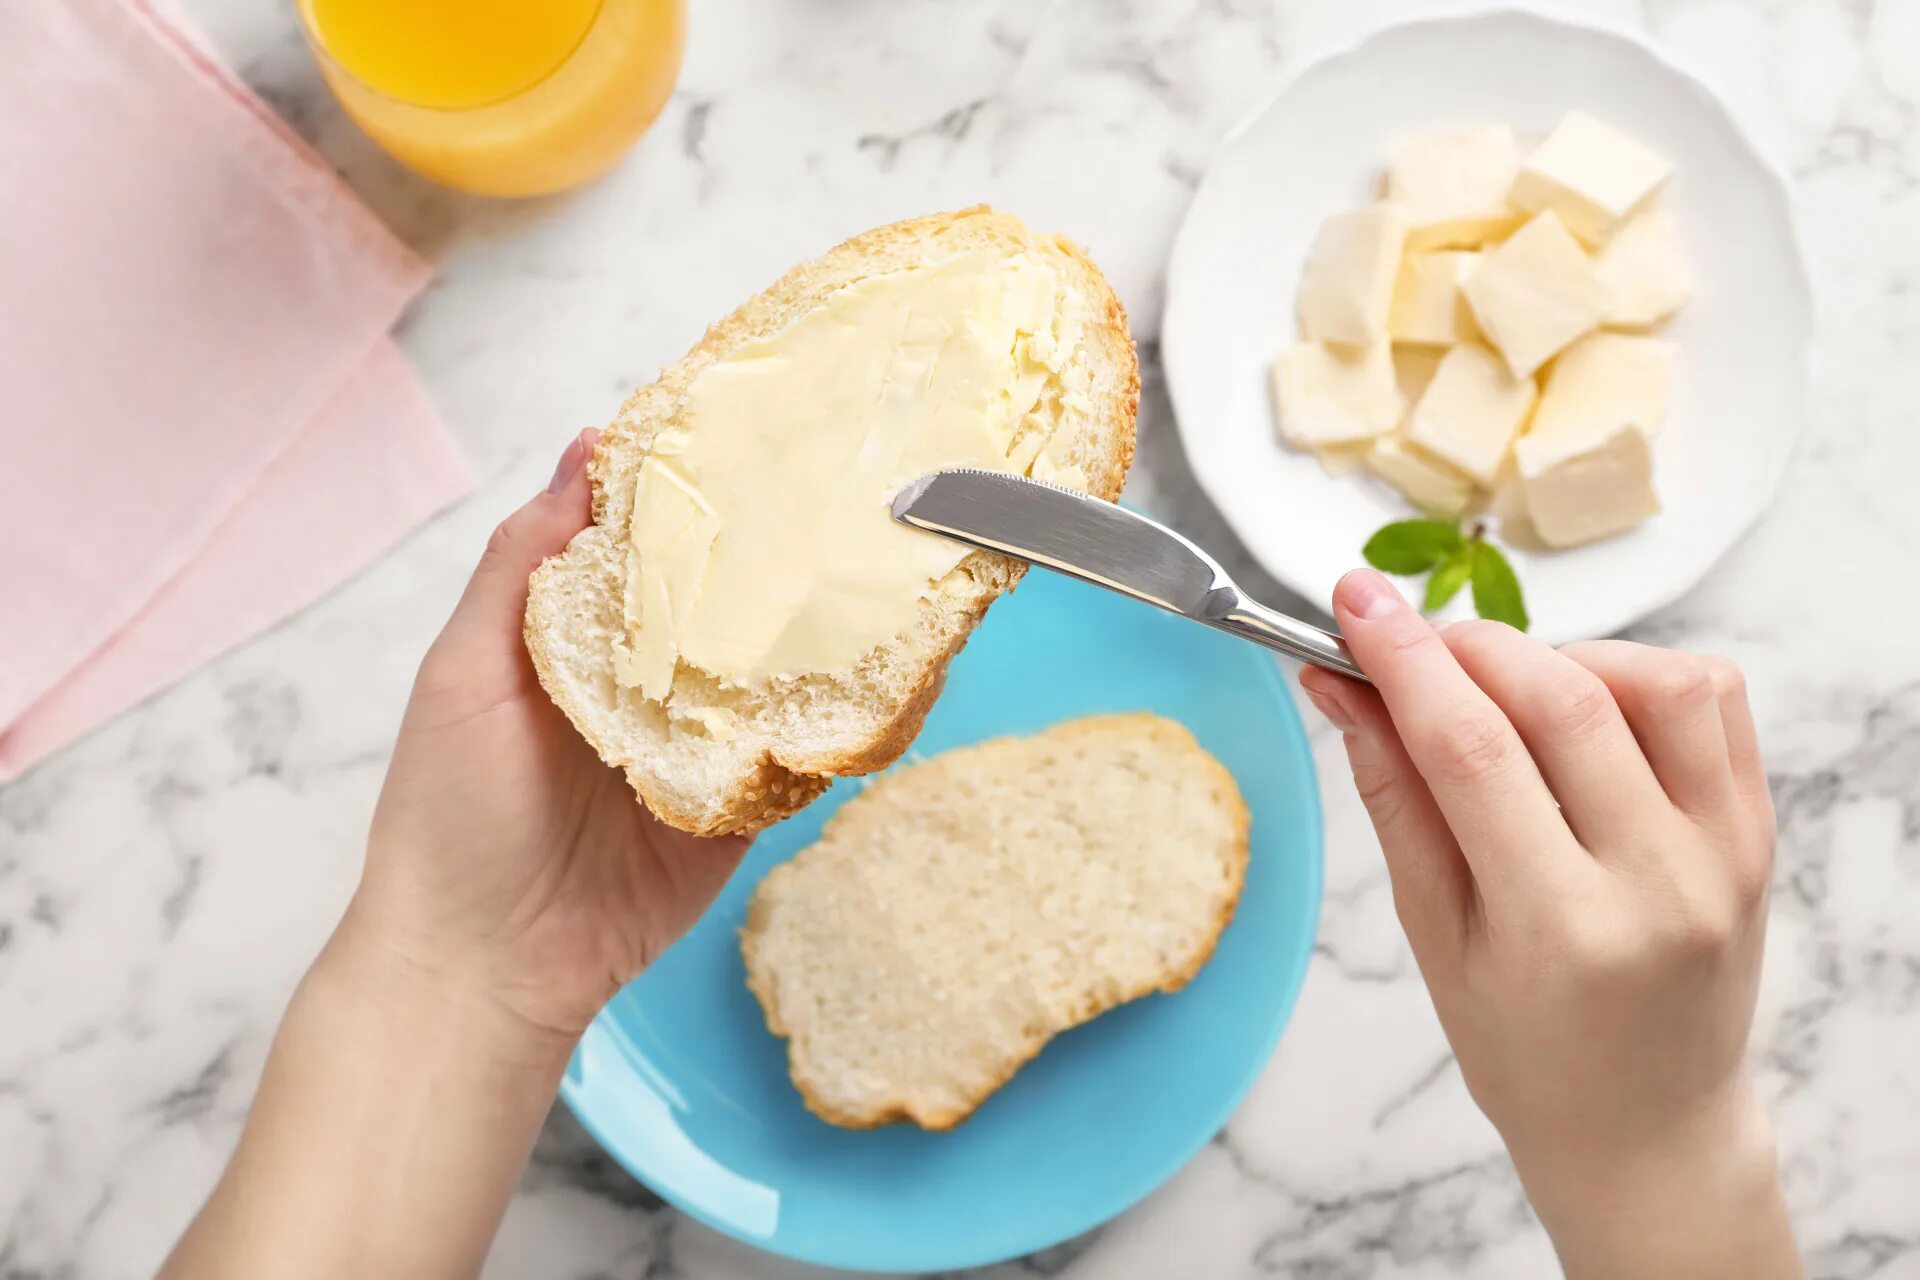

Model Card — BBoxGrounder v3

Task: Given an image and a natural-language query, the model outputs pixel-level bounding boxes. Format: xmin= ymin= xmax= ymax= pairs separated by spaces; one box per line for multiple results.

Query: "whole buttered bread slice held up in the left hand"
xmin=526 ymin=209 xmax=1139 ymax=835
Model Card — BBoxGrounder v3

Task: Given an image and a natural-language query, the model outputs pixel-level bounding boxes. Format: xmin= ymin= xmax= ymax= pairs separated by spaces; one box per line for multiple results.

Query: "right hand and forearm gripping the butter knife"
xmin=1300 ymin=570 xmax=1799 ymax=1278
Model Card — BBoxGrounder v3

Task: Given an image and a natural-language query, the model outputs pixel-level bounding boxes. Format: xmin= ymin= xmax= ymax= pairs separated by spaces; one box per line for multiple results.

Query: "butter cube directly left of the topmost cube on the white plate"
xmin=1386 ymin=125 xmax=1523 ymax=249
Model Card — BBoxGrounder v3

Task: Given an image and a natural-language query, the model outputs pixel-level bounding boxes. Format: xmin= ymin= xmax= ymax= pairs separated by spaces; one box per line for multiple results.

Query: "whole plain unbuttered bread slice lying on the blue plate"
xmin=741 ymin=714 xmax=1248 ymax=1128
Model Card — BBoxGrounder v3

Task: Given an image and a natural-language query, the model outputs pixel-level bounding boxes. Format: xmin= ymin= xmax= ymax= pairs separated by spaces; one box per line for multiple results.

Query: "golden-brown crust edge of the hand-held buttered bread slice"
xmin=524 ymin=205 xmax=1140 ymax=835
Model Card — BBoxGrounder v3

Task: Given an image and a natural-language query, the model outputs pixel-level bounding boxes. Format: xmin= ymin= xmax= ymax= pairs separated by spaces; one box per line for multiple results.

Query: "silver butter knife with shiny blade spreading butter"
xmin=893 ymin=466 xmax=1367 ymax=679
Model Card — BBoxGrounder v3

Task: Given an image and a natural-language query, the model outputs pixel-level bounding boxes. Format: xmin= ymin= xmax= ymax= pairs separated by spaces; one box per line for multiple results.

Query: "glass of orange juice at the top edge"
xmin=300 ymin=0 xmax=687 ymax=196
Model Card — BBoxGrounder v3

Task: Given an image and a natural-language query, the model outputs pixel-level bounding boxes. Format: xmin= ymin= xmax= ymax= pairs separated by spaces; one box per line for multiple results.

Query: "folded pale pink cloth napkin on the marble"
xmin=0 ymin=0 xmax=470 ymax=779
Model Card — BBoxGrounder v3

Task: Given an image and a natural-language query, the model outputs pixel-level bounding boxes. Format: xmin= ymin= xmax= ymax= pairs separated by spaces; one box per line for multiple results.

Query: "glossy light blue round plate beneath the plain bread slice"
xmin=561 ymin=570 xmax=1321 ymax=1270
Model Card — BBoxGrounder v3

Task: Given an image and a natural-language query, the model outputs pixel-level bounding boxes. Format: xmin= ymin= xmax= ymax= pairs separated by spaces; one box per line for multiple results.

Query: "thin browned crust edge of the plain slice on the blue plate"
xmin=739 ymin=712 xmax=1254 ymax=1132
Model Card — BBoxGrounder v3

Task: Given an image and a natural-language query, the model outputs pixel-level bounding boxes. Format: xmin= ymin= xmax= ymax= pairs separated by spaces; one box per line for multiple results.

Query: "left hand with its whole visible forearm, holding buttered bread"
xmin=161 ymin=432 xmax=747 ymax=1280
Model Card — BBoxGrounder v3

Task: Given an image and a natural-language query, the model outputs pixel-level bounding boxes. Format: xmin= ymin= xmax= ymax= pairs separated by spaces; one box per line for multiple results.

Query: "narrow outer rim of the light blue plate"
xmin=561 ymin=606 xmax=1327 ymax=1274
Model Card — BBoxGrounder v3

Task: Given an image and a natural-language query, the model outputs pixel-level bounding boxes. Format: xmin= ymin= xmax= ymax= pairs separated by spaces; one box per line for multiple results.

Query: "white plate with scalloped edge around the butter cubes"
xmin=1162 ymin=12 xmax=1812 ymax=645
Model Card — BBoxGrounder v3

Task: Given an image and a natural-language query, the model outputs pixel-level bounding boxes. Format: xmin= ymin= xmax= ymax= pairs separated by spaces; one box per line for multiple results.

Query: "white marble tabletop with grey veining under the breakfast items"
xmin=0 ymin=0 xmax=1920 ymax=1280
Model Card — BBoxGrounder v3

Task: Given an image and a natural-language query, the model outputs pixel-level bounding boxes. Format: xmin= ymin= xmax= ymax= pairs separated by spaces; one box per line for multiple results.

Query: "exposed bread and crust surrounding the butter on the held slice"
xmin=526 ymin=207 xmax=1140 ymax=835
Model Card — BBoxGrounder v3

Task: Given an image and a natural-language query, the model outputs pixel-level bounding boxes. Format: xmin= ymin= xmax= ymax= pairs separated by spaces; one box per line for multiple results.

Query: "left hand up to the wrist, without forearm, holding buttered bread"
xmin=344 ymin=432 xmax=747 ymax=1044
